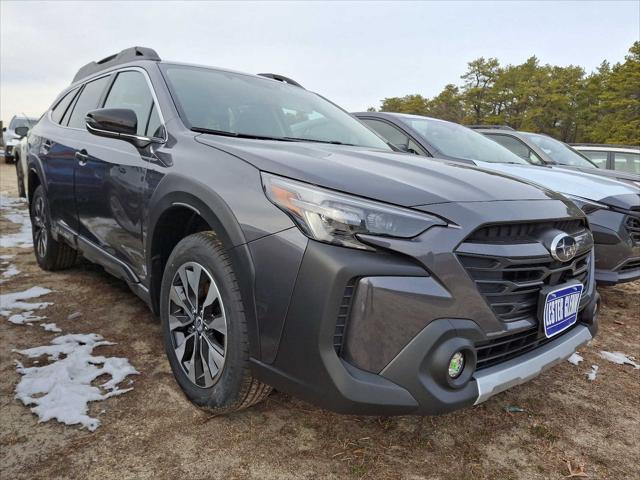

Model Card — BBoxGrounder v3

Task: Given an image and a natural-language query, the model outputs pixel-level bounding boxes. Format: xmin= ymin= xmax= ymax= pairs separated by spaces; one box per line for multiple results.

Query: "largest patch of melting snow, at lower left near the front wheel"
xmin=16 ymin=333 xmax=139 ymax=431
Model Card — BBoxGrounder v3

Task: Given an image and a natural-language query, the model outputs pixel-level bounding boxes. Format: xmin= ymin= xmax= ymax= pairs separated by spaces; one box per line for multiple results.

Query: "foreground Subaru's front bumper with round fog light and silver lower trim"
xmin=252 ymin=197 xmax=599 ymax=415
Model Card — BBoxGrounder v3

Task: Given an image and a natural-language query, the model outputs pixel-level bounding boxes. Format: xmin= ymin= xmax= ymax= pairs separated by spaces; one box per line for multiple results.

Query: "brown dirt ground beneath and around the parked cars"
xmin=0 ymin=164 xmax=640 ymax=479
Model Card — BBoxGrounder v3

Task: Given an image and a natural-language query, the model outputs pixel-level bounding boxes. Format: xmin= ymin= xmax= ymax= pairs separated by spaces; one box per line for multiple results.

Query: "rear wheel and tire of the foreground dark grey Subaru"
xmin=29 ymin=185 xmax=77 ymax=270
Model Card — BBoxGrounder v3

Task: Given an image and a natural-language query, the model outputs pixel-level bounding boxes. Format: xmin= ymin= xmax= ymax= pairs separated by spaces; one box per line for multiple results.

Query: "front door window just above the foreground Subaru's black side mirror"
xmin=104 ymin=71 xmax=157 ymax=136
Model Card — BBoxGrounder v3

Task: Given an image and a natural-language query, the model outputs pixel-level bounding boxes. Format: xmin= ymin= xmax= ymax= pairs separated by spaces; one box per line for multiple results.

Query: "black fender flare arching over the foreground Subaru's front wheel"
xmin=144 ymin=173 xmax=260 ymax=358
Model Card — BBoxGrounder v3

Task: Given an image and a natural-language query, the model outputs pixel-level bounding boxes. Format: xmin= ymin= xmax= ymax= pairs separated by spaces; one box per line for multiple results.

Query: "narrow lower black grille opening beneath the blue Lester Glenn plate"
xmin=476 ymin=323 xmax=577 ymax=370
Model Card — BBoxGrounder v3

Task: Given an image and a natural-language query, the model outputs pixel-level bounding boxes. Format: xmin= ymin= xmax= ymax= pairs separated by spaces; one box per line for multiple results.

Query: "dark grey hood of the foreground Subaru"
xmin=196 ymin=134 xmax=562 ymax=206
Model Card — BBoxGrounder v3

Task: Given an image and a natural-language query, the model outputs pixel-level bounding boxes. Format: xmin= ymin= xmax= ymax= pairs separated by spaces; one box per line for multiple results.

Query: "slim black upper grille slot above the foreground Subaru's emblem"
xmin=465 ymin=219 xmax=586 ymax=243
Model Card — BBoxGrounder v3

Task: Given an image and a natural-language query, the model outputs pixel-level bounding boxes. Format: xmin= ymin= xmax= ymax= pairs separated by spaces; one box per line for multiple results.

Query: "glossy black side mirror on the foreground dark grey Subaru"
xmin=85 ymin=108 xmax=153 ymax=148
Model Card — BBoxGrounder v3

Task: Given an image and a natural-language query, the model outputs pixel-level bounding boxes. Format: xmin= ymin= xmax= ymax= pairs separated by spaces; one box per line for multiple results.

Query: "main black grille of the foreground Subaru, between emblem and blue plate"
xmin=458 ymin=251 xmax=591 ymax=322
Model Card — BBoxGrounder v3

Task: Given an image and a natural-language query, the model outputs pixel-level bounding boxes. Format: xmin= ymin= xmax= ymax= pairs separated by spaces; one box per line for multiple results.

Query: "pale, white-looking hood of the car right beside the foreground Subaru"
xmin=475 ymin=161 xmax=640 ymax=202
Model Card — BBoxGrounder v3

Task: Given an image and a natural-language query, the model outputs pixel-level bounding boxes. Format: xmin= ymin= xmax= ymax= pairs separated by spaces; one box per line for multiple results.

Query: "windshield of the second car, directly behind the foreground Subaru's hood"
xmin=402 ymin=117 xmax=527 ymax=165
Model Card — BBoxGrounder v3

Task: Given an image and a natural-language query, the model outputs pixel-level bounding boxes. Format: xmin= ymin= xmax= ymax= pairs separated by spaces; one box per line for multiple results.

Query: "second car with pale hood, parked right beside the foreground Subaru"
xmin=354 ymin=112 xmax=640 ymax=284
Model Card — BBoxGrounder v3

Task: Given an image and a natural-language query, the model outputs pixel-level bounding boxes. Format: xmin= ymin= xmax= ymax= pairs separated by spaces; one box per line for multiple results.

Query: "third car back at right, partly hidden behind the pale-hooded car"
xmin=469 ymin=125 xmax=640 ymax=187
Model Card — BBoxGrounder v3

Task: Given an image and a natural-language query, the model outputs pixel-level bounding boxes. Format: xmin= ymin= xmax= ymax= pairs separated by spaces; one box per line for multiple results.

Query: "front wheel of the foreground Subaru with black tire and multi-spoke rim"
xmin=160 ymin=232 xmax=271 ymax=414
